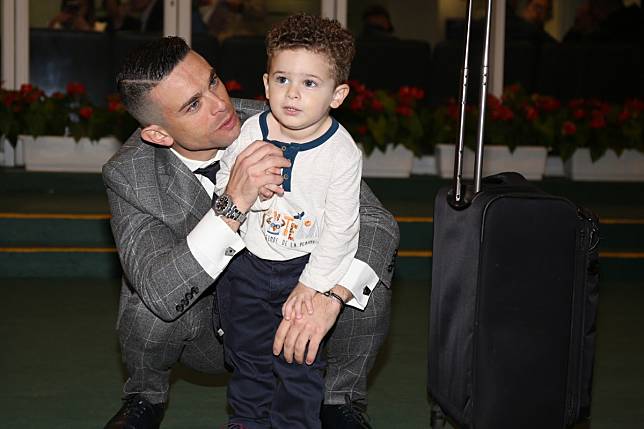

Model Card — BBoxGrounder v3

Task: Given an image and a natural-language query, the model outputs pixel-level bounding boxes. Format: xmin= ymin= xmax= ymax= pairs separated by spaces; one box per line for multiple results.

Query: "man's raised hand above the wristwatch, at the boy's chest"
xmin=225 ymin=141 xmax=291 ymax=213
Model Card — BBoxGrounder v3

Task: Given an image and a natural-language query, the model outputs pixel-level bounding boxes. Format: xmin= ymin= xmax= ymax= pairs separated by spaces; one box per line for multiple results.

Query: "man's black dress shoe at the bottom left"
xmin=105 ymin=394 xmax=165 ymax=429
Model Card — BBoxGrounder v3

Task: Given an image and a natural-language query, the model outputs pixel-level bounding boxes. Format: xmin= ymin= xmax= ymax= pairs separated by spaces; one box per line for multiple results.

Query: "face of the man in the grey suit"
xmin=150 ymin=51 xmax=239 ymax=160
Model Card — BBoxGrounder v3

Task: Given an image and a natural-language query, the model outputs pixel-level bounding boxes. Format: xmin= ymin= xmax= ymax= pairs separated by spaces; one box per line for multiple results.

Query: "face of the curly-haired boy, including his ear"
xmin=264 ymin=49 xmax=349 ymax=136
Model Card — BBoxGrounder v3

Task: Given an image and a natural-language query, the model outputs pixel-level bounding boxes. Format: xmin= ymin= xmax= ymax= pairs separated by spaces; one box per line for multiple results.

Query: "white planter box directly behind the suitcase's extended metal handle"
xmin=435 ymin=144 xmax=548 ymax=180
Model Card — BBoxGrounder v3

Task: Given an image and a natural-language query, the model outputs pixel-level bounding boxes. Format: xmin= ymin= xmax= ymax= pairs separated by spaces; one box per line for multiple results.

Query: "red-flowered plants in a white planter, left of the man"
xmin=1 ymin=82 xmax=137 ymax=172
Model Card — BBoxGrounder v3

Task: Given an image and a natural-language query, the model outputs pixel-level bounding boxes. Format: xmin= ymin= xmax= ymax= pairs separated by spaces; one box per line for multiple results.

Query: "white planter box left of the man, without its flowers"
xmin=19 ymin=136 xmax=121 ymax=173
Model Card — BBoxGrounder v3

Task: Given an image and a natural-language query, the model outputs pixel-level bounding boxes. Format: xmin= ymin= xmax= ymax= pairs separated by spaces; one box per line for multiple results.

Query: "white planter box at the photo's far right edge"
xmin=564 ymin=148 xmax=644 ymax=182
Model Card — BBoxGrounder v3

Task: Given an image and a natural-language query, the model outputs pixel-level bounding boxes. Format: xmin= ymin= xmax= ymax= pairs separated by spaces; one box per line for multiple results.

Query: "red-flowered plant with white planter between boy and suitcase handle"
xmin=334 ymin=81 xmax=432 ymax=177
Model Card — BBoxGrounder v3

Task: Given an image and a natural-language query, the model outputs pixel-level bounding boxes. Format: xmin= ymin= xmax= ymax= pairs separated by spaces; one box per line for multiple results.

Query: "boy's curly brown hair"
xmin=266 ymin=13 xmax=356 ymax=85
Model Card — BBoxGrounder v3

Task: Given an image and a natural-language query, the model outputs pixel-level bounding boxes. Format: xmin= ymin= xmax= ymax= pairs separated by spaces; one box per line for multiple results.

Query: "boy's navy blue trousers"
xmin=217 ymin=250 xmax=325 ymax=429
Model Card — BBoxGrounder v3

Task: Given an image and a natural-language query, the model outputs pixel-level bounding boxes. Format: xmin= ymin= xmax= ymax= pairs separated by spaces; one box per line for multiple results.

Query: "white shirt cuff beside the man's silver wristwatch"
xmin=187 ymin=210 xmax=245 ymax=280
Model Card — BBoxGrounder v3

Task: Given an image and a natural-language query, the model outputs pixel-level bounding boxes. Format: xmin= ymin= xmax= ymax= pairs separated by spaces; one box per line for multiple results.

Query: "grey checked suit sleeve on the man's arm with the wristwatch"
xmin=103 ymin=163 xmax=239 ymax=322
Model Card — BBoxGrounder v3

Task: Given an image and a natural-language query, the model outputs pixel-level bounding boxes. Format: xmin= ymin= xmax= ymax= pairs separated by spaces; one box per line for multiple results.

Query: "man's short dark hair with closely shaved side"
xmin=116 ymin=36 xmax=190 ymax=126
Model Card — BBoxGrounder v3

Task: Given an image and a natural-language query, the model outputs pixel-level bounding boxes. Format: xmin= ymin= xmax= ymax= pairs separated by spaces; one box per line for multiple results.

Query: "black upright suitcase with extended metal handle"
xmin=427 ymin=0 xmax=599 ymax=429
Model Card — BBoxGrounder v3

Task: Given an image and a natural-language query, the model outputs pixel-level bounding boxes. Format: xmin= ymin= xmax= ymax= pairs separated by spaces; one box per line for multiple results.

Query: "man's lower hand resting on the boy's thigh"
xmin=273 ymin=286 xmax=351 ymax=365
